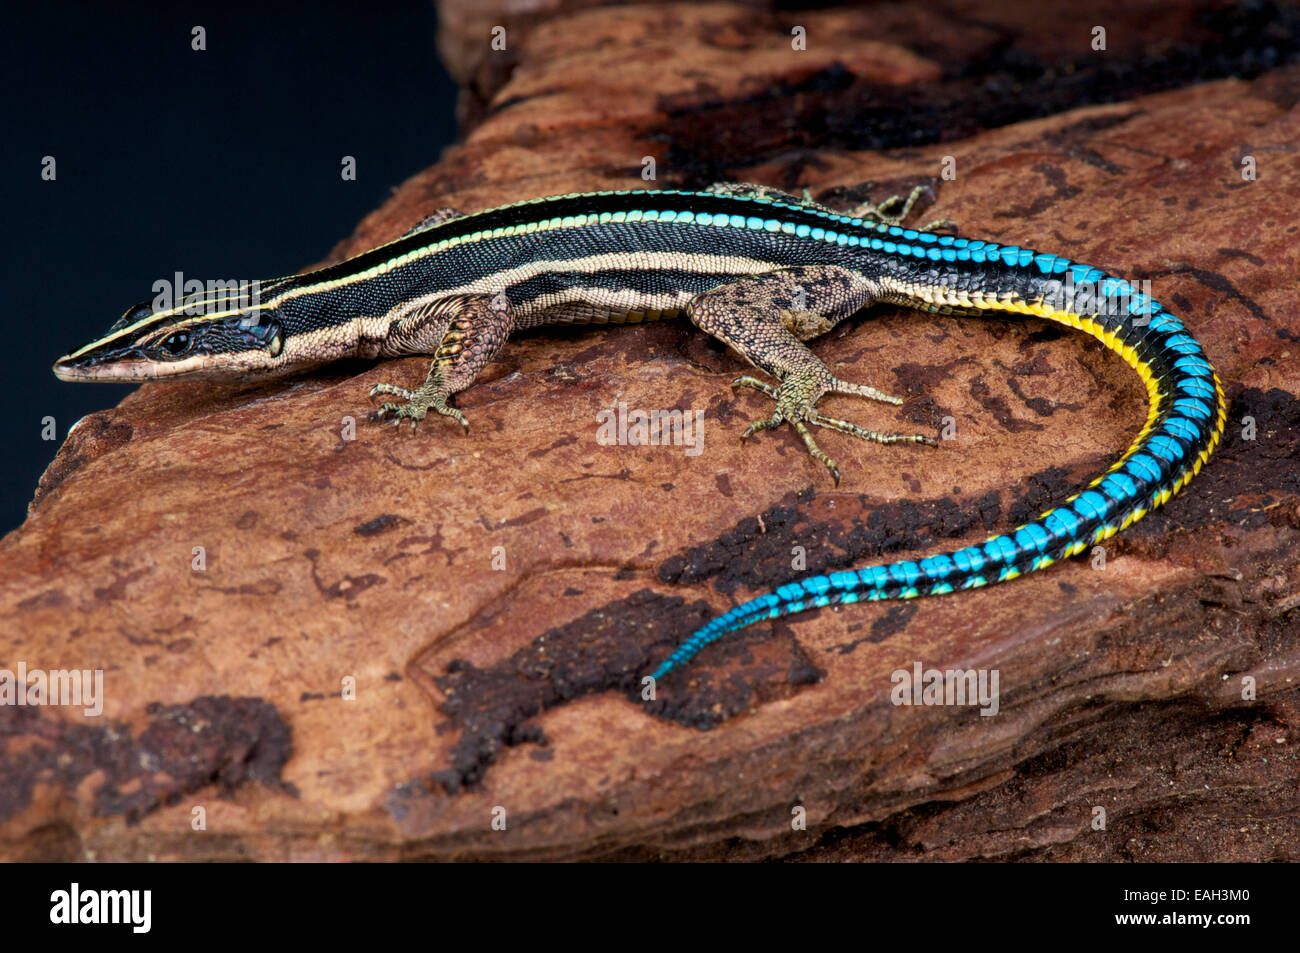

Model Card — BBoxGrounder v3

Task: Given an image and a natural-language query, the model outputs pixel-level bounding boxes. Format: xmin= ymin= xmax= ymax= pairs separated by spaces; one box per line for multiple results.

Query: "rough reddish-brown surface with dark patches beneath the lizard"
xmin=0 ymin=3 xmax=1300 ymax=861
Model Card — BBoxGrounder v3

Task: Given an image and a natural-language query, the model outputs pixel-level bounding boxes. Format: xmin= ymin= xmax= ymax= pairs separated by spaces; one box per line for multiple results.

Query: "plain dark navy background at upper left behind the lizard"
xmin=0 ymin=0 xmax=455 ymax=533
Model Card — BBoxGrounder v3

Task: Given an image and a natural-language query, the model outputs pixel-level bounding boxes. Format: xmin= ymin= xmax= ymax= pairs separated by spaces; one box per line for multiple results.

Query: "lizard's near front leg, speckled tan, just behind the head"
xmin=371 ymin=294 xmax=514 ymax=433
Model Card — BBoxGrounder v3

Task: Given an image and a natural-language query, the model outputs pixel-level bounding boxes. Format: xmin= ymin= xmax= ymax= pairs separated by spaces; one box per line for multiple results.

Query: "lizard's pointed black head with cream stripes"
xmin=53 ymin=286 xmax=289 ymax=384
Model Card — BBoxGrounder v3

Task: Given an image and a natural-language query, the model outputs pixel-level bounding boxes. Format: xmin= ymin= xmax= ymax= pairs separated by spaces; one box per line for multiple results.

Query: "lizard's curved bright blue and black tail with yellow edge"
xmin=653 ymin=256 xmax=1227 ymax=679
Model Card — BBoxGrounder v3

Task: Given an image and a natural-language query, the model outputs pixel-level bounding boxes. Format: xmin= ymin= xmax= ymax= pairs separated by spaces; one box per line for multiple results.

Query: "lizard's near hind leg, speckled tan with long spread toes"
xmin=686 ymin=265 xmax=937 ymax=485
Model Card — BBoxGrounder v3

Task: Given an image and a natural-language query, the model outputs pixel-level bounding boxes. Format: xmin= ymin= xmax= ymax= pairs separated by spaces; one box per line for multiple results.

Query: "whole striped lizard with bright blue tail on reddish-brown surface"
xmin=53 ymin=182 xmax=1227 ymax=679
